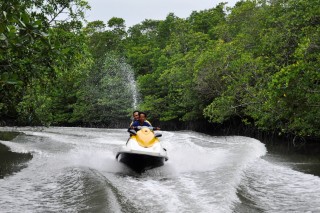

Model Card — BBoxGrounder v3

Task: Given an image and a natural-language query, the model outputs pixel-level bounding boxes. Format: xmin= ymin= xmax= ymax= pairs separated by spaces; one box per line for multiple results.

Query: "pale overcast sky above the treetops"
xmin=86 ymin=0 xmax=238 ymax=27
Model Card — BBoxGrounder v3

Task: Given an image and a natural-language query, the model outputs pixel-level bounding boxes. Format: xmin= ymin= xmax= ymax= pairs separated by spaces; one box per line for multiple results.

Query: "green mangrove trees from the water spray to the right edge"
xmin=126 ymin=0 xmax=320 ymax=136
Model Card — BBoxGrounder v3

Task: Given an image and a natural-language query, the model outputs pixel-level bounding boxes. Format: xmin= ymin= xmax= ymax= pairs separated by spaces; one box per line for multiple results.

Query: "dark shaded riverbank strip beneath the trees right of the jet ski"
xmin=155 ymin=120 xmax=320 ymax=156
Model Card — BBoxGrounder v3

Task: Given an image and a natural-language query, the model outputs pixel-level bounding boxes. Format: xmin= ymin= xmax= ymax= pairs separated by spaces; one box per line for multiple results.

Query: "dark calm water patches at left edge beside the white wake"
xmin=0 ymin=132 xmax=32 ymax=179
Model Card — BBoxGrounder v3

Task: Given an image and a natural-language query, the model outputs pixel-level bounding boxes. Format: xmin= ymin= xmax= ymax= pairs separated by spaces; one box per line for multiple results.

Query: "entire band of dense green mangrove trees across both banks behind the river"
xmin=0 ymin=0 xmax=320 ymax=137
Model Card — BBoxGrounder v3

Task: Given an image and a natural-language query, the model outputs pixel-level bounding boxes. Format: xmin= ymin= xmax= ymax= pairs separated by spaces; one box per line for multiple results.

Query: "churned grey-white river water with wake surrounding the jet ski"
xmin=0 ymin=127 xmax=320 ymax=212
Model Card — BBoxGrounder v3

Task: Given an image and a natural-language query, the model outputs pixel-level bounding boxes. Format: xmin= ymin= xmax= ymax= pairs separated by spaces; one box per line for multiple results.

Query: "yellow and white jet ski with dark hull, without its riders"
xmin=116 ymin=126 xmax=168 ymax=173
